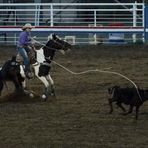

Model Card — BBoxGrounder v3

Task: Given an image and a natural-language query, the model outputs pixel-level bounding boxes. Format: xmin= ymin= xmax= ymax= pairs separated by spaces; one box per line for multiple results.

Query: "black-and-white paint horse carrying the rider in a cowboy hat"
xmin=0 ymin=34 xmax=71 ymax=100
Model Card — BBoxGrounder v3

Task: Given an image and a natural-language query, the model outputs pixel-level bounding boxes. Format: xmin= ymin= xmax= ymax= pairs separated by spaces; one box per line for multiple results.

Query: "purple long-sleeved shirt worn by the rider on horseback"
xmin=17 ymin=31 xmax=31 ymax=46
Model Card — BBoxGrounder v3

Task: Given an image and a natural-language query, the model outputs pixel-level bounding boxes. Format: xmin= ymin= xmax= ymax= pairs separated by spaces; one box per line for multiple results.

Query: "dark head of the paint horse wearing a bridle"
xmin=46 ymin=34 xmax=72 ymax=51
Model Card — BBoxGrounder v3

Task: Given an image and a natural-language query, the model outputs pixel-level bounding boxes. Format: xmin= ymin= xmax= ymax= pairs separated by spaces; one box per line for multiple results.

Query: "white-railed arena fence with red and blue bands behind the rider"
xmin=0 ymin=2 xmax=148 ymax=44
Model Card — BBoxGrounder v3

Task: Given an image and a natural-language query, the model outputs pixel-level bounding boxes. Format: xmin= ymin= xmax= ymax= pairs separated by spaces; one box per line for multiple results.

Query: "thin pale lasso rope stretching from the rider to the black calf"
xmin=32 ymin=37 xmax=142 ymax=101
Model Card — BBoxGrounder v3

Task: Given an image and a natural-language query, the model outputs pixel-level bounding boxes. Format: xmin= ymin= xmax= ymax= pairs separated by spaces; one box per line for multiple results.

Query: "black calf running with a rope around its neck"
xmin=108 ymin=86 xmax=148 ymax=119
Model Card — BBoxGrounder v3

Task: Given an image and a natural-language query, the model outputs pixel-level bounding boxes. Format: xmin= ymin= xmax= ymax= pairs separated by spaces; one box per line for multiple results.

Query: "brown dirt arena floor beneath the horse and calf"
xmin=0 ymin=45 xmax=148 ymax=148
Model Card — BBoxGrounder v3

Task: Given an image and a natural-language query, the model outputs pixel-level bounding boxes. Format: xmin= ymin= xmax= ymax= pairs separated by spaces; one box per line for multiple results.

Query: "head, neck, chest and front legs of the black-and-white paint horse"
xmin=27 ymin=34 xmax=72 ymax=99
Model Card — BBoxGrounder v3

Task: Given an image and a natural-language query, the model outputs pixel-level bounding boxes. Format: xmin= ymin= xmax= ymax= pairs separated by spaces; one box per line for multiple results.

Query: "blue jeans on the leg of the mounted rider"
xmin=17 ymin=47 xmax=30 ymax=72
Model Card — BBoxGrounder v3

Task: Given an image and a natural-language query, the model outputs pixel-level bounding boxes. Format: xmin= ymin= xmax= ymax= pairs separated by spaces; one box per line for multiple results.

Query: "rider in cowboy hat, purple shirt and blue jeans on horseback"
xmin=17 ymin=23 xmax=34 ymax=78
